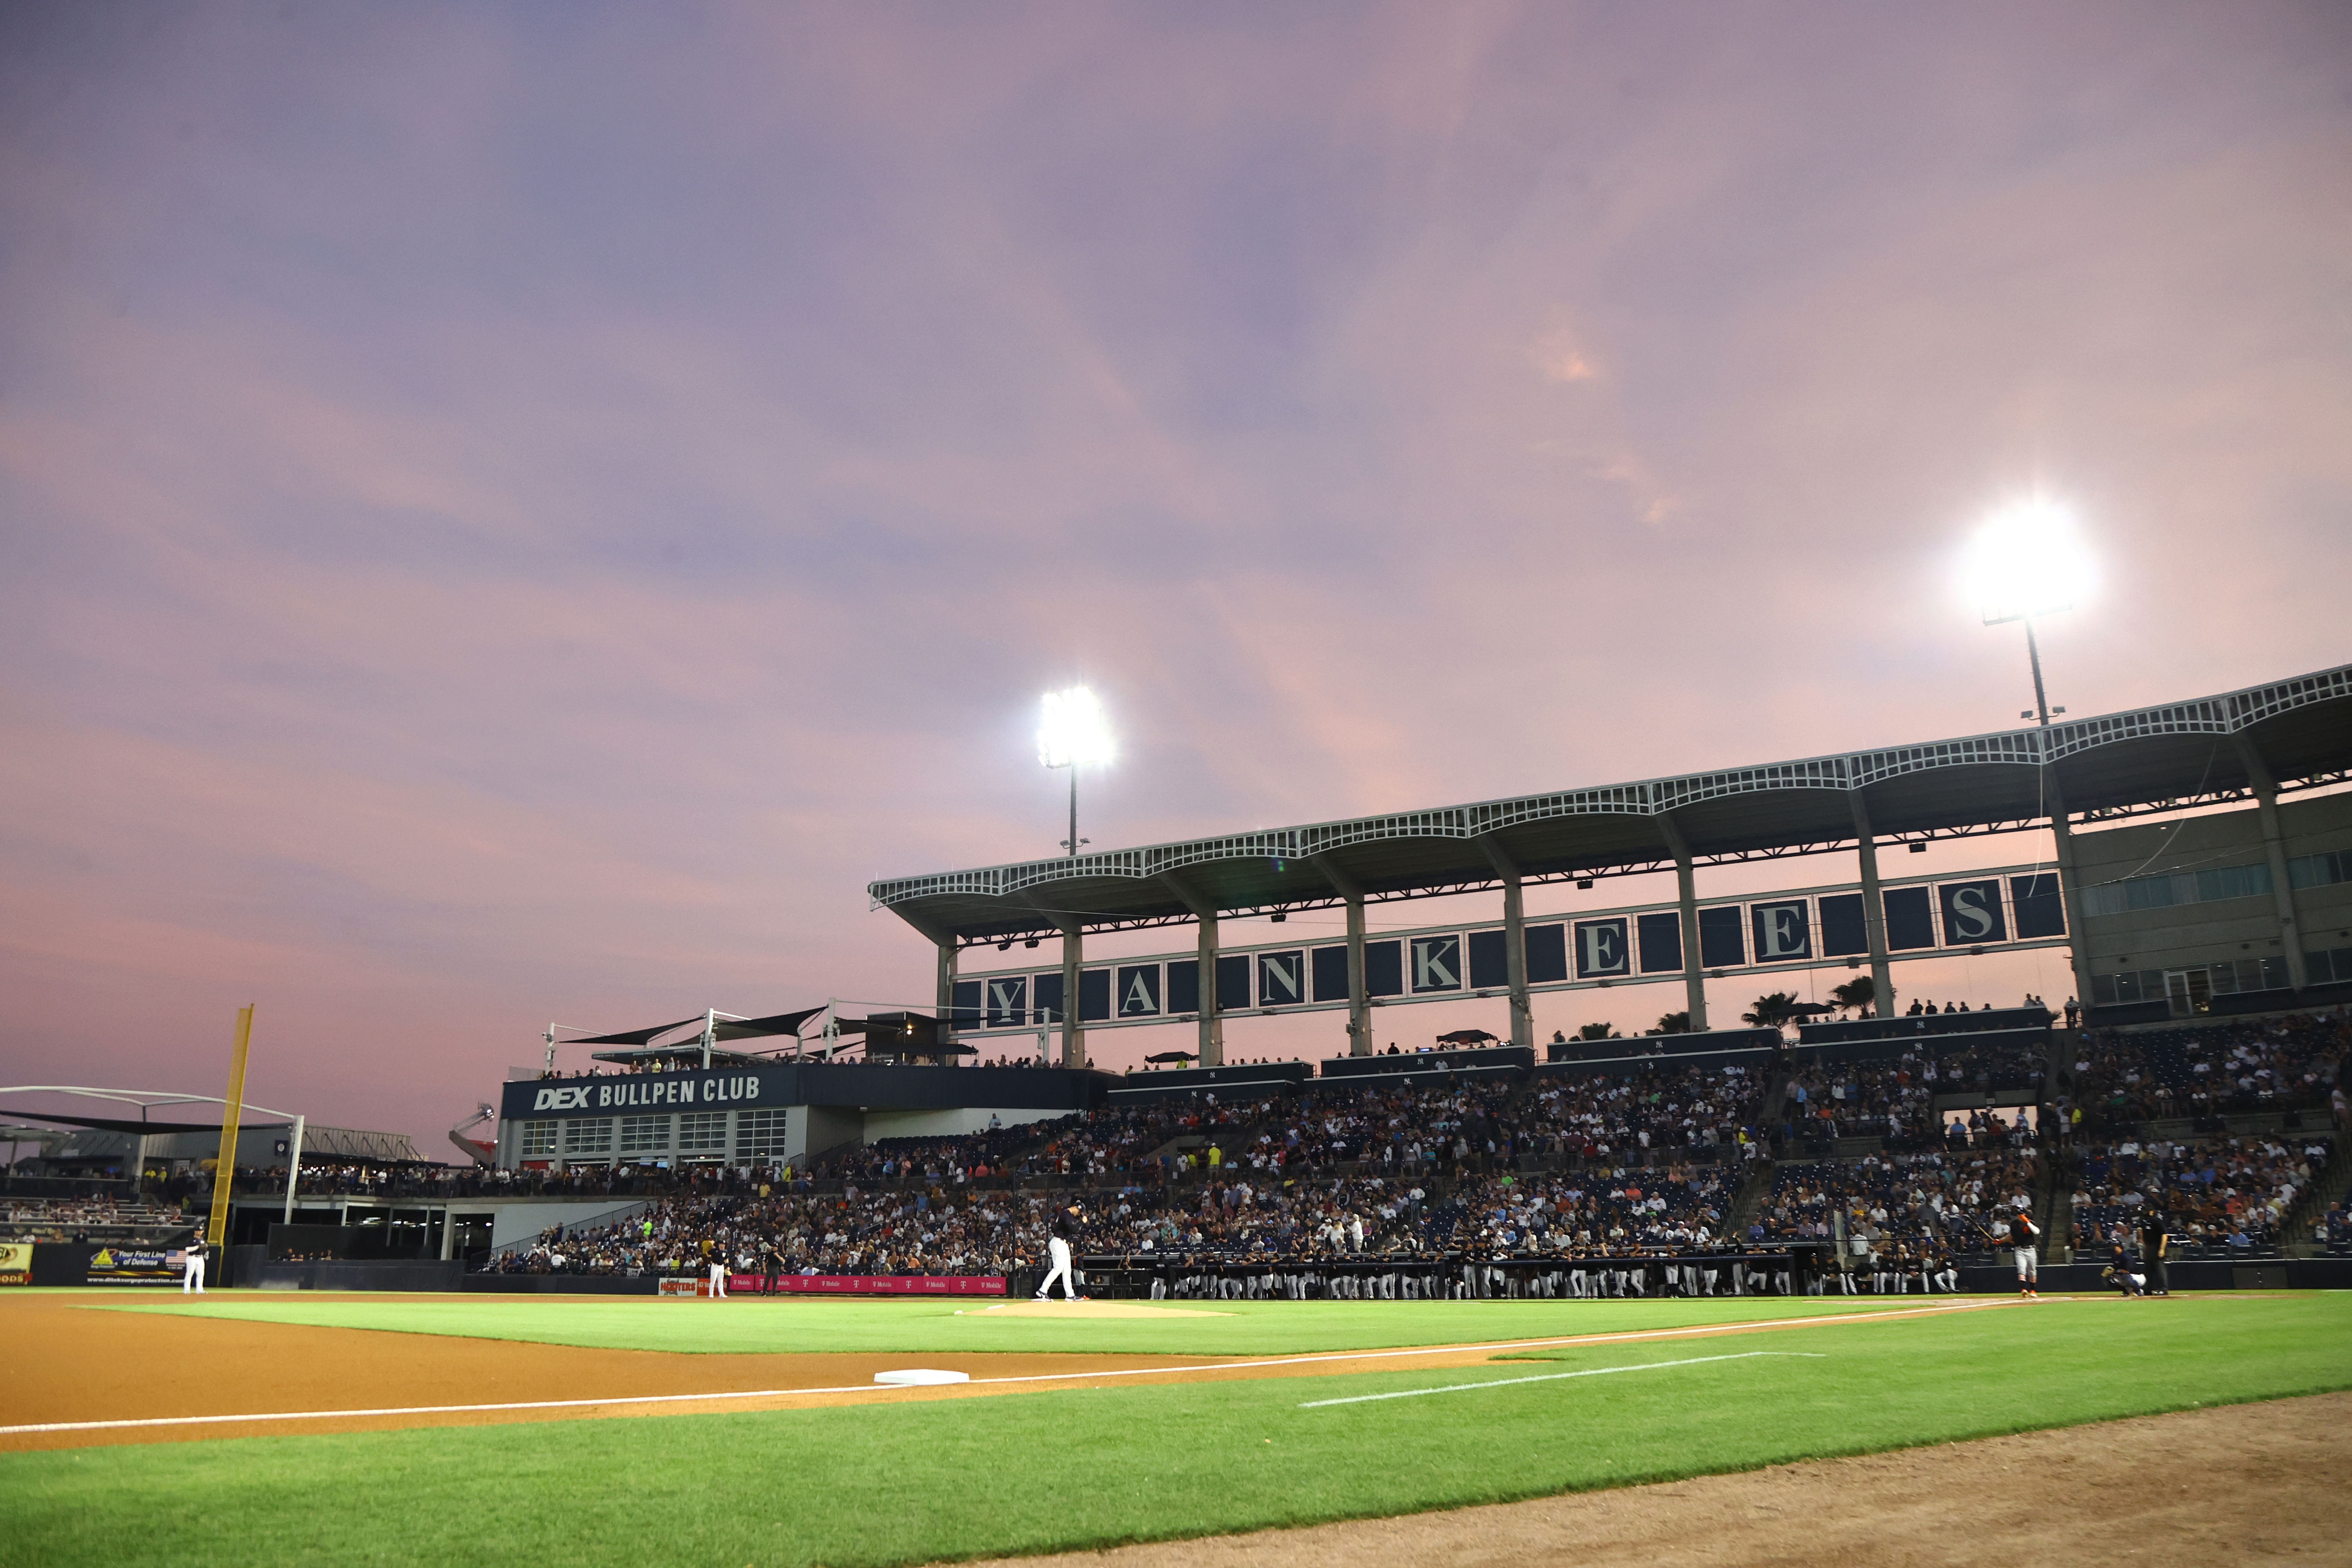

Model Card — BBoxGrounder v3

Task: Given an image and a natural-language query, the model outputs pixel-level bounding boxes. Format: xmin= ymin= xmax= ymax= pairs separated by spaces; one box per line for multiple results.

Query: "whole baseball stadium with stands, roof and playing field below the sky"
xmin=0 ymin=665 xmax=2352 ymax=1568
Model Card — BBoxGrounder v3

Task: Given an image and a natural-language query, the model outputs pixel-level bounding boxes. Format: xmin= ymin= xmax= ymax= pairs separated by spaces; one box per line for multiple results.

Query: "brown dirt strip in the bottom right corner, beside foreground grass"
xmin=964 ymin=1394 xmax=2352 ymax=1568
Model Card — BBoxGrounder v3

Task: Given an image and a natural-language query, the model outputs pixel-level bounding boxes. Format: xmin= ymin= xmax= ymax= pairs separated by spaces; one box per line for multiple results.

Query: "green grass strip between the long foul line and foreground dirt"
xmin=0 ymin=1295 xmax=2352 ymax=1568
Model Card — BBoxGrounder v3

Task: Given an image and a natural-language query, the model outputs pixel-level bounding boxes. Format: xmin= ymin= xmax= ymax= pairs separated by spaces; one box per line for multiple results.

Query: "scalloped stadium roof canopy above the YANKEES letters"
xmin=865 ymin=665 xmax=2352 ymax=945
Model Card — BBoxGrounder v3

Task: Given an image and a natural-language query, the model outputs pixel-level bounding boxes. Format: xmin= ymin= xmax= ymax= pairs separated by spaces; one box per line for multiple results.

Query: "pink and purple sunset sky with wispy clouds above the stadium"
xmin=0 ymin=0 xmax=2352 ymax=1150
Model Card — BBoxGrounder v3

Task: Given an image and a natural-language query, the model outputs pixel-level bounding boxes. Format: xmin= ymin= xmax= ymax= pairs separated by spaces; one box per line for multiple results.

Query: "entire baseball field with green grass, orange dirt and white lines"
xmin=0 ymin=1291 xmax=2352 ymax=1568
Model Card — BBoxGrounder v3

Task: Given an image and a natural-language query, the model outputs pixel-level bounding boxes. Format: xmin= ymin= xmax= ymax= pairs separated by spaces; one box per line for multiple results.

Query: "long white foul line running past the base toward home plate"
xmin=0 ymin=1295 xmax=2016 ymax=1436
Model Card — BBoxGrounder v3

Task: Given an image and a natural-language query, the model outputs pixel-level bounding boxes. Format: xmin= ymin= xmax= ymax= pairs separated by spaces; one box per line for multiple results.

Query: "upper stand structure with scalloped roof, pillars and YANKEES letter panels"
xmin=868 ymin=668 xmax=2352 ymax=1067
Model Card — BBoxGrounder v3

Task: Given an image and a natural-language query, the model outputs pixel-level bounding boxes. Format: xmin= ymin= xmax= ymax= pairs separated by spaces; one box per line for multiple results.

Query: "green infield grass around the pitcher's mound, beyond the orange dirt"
xmin=101 ymin=1293 xmax=1985 ymax=1356
